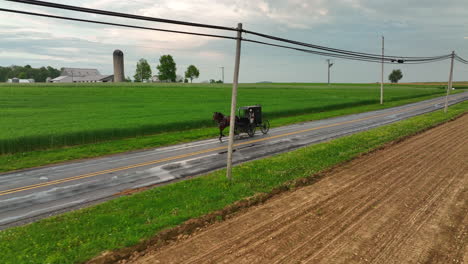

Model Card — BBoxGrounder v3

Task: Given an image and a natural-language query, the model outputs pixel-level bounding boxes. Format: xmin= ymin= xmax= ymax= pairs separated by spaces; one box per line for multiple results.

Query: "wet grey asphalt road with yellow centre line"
xmin=0 ymin=92 xmax=468 ymax=229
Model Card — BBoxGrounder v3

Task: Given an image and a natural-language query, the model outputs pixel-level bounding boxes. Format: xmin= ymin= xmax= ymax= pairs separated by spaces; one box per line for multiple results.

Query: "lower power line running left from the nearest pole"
xmin=0 ymin=8 xmax=236 ymax=39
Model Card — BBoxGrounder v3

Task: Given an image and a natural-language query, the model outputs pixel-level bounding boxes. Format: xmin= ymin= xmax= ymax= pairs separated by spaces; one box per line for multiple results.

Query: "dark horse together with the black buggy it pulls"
xmin=213 ymin=105 xmax=270 ymax=142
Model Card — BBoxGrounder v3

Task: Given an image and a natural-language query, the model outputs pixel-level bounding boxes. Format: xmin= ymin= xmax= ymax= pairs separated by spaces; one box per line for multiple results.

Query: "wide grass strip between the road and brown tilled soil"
xmin=0 ymin=102 xmax=468 ymax=263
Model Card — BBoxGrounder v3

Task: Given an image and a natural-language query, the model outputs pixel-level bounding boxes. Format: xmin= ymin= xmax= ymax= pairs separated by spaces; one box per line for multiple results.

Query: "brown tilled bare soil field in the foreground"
xmin=126 ymin=115 xmax=468 ymax=263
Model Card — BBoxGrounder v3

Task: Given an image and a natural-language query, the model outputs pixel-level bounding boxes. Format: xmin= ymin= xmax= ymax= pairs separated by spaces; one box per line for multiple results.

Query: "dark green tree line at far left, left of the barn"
xmin=0 ymin=65 xmax=60 ymax=82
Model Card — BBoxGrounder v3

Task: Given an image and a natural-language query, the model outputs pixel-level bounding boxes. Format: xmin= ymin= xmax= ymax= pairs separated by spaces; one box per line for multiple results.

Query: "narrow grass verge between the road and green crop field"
xmin=0 ymin=91 xmax=461 ymax=172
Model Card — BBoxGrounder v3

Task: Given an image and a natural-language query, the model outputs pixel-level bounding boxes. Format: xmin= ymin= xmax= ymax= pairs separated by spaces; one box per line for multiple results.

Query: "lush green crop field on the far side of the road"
xmin=0 ymin=83 xmax=454 ymax=154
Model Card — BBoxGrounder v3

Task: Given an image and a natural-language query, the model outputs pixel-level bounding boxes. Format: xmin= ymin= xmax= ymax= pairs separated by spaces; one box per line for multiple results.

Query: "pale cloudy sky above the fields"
xmin=0 ymin=0 xmax=468 ymax=82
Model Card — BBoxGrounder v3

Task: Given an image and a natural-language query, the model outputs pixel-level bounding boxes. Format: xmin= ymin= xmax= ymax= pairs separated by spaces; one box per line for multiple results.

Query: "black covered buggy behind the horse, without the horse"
xmin=234 ymin=105 xmax=270 ymax=137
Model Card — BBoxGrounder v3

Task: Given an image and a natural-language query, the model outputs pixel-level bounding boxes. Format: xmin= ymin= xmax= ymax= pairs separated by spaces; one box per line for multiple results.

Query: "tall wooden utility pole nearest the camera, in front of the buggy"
xmin=226 ymin=23 xmax=242 ymax=180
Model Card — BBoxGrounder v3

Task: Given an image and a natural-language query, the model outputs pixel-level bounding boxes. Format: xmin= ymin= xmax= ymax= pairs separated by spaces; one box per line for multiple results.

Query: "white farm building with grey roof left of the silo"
xmin=51 ymin=68 xmax=114 ymax=83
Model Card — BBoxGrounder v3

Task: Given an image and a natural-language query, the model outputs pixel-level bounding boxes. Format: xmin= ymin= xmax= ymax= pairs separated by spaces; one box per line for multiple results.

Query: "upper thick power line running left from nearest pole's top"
xmin=6 ymin=0 xmax=237 ymax=31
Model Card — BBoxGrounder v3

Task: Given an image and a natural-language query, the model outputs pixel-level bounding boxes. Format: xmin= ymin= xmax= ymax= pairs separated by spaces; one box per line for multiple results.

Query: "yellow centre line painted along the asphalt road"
xmin=0 ymin=94 xmax=460 ymax=196
